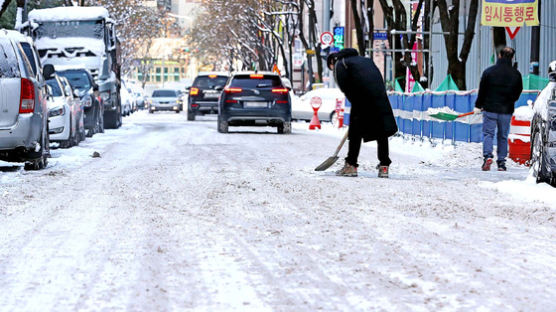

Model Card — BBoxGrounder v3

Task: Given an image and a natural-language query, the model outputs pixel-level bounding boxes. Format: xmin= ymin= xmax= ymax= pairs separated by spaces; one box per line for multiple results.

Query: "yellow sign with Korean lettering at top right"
xmin=481 ymin=0 xmax=539 ymax=27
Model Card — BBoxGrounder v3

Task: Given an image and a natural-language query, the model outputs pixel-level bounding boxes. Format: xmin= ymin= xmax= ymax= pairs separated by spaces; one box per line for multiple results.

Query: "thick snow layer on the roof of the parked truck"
xmin=29 ymin=6 xmax=109 ymax=22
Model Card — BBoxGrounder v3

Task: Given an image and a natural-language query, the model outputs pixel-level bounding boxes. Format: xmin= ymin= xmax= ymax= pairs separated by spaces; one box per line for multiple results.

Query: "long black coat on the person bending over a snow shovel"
xmin=334 ymin=49 xmax=398 ymax=142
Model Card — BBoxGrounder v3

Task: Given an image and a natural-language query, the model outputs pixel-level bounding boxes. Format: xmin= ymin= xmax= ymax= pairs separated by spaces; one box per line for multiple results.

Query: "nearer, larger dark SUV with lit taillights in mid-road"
xmin=218 ymin=72 xmax=292 ymax=133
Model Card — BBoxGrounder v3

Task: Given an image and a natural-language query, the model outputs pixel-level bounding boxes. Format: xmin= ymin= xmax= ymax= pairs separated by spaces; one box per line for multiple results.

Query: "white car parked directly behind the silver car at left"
xmin=45 ymin=65 xmax=86 ymax=148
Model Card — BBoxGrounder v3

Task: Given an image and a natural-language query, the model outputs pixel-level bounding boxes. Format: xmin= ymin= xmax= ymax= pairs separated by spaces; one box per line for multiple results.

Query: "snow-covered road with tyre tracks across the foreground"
xmin=0 ymin=112 xmax=556 ymax=311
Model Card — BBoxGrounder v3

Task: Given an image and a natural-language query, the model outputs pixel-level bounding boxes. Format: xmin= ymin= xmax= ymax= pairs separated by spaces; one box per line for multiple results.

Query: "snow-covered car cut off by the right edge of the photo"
xmin=531 ymin=61 xmax=556 ymax=187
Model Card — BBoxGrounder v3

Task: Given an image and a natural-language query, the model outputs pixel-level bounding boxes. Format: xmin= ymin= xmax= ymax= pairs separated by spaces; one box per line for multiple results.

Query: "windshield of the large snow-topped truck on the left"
xmin=35 ymin=20 xmax=104 ymax=39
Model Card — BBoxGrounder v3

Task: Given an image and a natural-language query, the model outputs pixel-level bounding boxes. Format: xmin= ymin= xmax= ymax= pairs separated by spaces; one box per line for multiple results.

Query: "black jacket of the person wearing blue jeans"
xmin=475 ymin=59 xmax=523 ymax=114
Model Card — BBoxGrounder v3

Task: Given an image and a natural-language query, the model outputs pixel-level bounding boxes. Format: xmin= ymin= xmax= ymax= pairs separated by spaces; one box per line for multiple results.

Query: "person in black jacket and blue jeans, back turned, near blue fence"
xmin=474 ymin=47 xmax=523 ymax=171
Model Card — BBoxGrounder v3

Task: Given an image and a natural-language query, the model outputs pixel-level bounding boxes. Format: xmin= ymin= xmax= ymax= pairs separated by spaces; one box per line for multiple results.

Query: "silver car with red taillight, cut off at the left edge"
xmin=0 ymin=30 xmax=50 ymax=170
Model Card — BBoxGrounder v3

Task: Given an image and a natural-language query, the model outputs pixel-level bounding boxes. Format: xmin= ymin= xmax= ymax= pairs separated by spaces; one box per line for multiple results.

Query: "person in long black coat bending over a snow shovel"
xmin=327 ymin=49 xmax=398 ymax=178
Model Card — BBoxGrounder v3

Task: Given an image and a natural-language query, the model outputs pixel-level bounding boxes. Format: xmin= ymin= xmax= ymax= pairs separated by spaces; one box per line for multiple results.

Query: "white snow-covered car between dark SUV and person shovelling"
xmin=292 ymin=88 xmax=345 ymax=123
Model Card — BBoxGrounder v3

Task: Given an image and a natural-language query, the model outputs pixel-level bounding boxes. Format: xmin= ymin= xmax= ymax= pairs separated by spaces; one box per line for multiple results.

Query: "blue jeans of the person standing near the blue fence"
xmin=483 ymin=112 xmax=512 ymax=164
